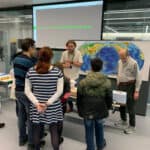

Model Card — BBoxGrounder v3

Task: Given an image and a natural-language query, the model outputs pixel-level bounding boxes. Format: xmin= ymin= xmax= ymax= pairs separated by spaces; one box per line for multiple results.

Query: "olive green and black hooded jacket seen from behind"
xmin=77 ymin=72 xmax=112 ymax=119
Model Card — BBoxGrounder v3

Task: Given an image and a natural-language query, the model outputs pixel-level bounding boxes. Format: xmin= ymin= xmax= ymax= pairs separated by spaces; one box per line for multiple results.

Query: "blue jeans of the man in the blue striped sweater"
xmin=16 ymin=91 xmax=33 ymax=144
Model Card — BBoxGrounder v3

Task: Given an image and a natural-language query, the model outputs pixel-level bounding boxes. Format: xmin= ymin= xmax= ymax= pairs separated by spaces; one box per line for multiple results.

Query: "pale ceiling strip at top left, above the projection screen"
xmin=0 ymin=0 xmax=73 ymax=8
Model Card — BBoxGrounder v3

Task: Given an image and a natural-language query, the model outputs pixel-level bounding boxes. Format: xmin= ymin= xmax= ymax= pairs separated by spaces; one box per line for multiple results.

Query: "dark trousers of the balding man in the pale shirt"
xmin=118 ymin=83 xmax=136 ymax=127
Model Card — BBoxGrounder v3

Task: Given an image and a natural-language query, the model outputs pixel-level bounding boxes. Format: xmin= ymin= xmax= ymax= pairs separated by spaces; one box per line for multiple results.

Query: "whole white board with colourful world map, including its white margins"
xmin=76 ymin=41 xmax=150 ymax=81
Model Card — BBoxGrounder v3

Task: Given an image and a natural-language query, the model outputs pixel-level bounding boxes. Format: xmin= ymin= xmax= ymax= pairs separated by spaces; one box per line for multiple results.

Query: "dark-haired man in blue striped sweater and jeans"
xmin=13 ymin=38 xmax=35 ymax=146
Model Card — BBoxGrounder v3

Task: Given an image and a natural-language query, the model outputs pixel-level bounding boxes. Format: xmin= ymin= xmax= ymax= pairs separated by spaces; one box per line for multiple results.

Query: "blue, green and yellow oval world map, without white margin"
xmin=78 ymin=41 xmax=144 ymax=75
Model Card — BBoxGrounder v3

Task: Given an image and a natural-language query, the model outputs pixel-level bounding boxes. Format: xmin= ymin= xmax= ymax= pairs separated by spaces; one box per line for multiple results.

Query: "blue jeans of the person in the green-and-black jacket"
xmin=84 ymin=119 xmax=104 ymax=150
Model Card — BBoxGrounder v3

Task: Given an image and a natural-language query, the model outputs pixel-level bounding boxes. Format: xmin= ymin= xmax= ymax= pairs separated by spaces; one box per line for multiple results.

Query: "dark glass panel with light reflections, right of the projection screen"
xmin=103 ymin=0 xmax=150 ymax=33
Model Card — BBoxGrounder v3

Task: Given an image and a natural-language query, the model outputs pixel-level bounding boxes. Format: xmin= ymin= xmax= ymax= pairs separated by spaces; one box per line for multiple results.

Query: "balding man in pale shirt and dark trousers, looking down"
xmin=116 ymin=49 xmax=141 ymax=134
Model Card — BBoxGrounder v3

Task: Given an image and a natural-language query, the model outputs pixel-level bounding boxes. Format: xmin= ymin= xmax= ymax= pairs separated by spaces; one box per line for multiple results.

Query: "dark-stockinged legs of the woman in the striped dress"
xmin=33 ymin=122 xmax=62 ymax=150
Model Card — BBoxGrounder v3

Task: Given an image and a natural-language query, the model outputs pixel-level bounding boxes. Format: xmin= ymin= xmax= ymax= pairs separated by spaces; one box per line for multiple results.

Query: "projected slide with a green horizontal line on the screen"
xmin=33 ymin=0 xmax=103 ymax=48
